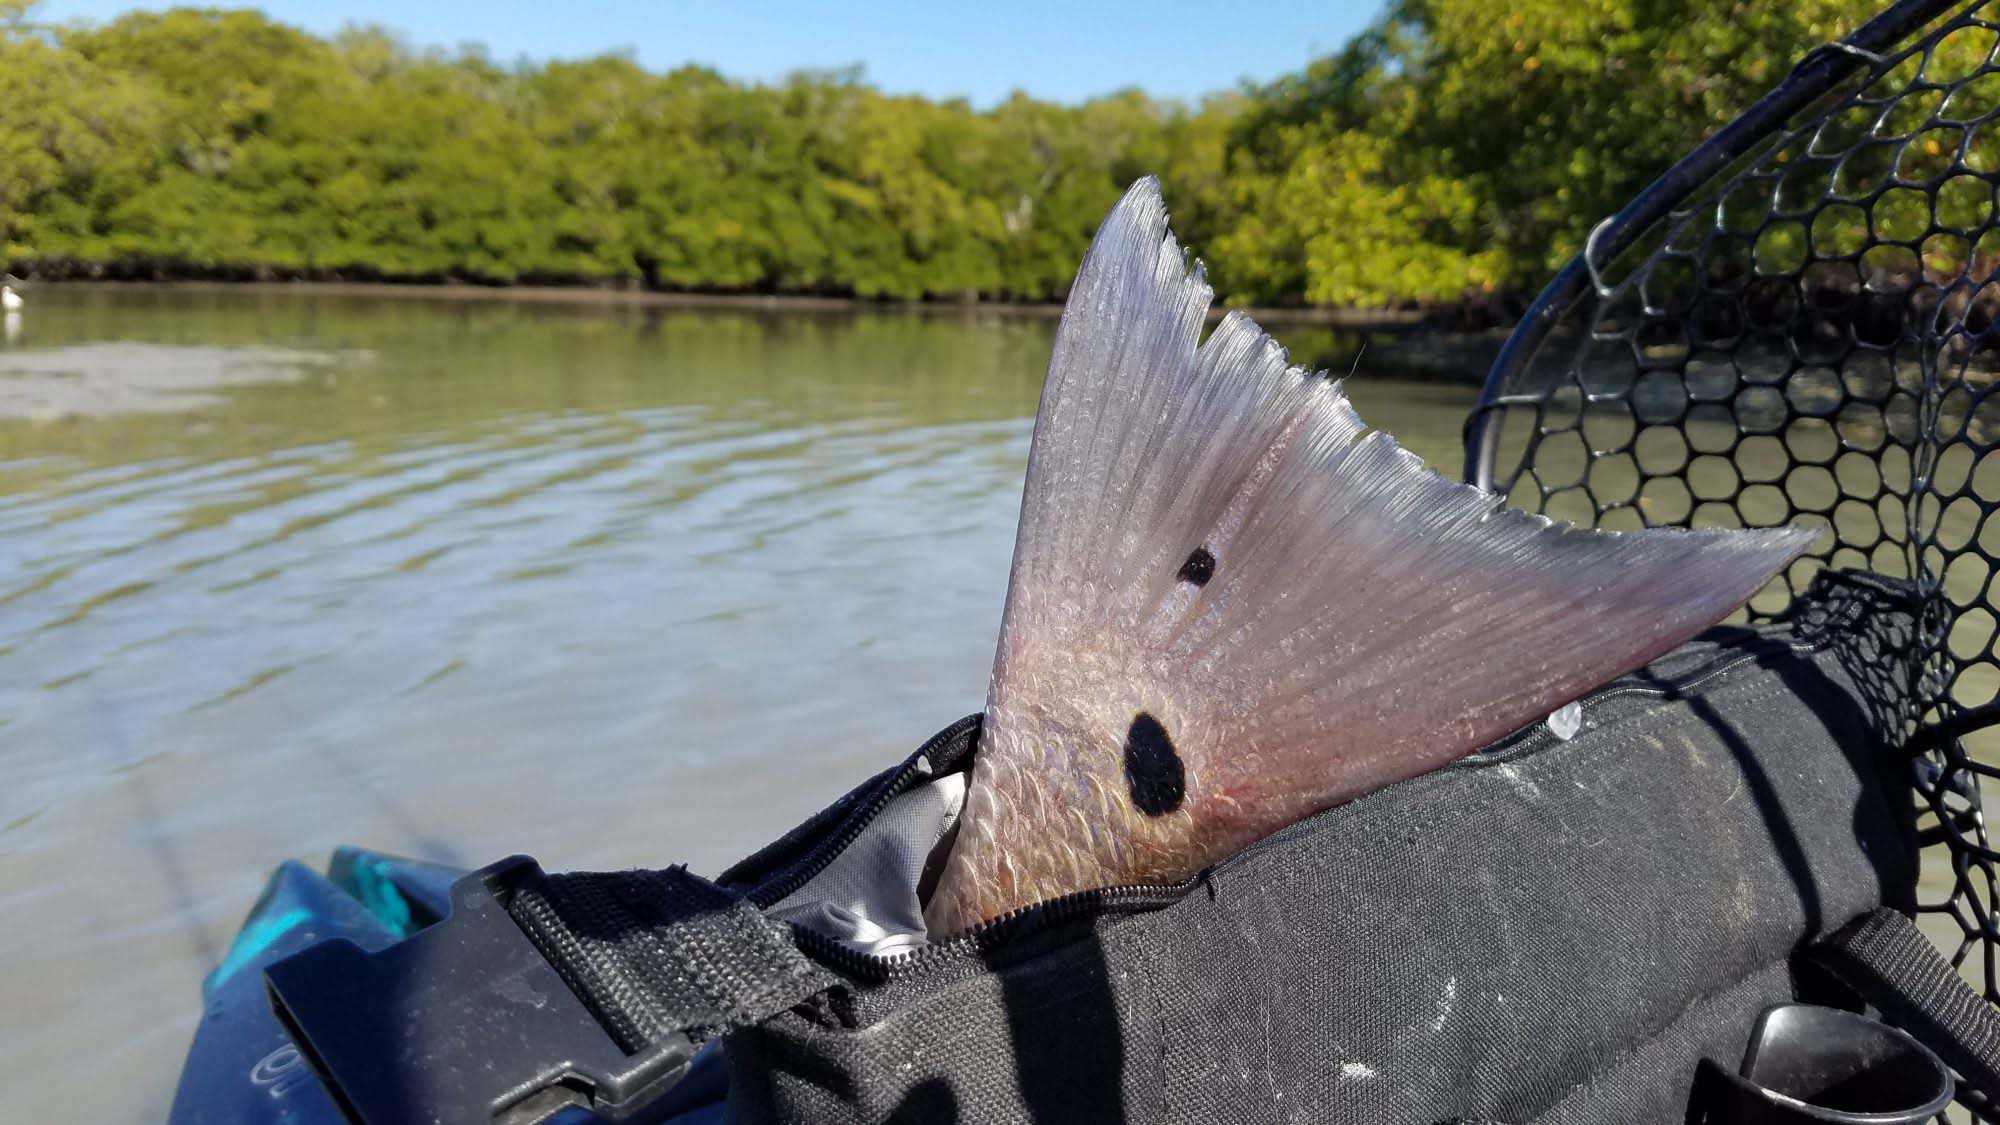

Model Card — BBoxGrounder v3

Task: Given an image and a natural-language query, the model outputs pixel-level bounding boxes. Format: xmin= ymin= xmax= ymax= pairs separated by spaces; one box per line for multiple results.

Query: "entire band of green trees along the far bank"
xmin=0 ymin=0 xmax=1874 ymax=306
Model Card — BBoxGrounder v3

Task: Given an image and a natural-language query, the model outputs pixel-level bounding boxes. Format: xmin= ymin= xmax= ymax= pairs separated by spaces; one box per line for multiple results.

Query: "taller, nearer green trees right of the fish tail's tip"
xmin=1216 ymin=0 xmax=1878 ymax=304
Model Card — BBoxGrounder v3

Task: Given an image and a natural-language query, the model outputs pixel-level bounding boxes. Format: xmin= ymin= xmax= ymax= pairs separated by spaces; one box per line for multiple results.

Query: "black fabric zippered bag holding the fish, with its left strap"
xmin=446 ymin=575 xmax=1960 ymax=1125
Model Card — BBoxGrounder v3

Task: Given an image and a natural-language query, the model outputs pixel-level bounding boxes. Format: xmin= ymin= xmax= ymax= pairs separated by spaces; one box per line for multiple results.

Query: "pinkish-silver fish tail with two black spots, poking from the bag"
xmin=926 ymin=178 xmax=1816 ymax=935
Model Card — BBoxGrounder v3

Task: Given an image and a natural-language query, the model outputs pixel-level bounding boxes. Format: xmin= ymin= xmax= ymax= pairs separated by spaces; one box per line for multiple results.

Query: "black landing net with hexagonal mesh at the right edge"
xmin=1466 ymin=0 xmax=2000 ymax=1088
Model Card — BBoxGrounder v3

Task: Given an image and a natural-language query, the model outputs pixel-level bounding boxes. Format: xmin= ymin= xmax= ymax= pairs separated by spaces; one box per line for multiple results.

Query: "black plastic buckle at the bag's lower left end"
xmin=264 ymin=855 xmax=694 ymax=1125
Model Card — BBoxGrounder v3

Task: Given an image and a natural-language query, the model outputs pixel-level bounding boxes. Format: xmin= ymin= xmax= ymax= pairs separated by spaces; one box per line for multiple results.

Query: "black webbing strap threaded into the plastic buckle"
xmin=508 ymin=867 xmax=834 ymax=1053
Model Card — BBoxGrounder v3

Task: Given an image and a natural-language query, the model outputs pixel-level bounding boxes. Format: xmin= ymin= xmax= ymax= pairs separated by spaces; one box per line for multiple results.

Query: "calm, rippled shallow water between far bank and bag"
xmin=0 ymin=286 xmax=1472 ymax=1121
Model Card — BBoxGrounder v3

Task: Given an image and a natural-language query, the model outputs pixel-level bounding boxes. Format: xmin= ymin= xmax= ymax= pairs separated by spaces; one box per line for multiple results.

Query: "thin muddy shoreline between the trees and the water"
xmin=22 ymin=278 xmax=1426 ymax=332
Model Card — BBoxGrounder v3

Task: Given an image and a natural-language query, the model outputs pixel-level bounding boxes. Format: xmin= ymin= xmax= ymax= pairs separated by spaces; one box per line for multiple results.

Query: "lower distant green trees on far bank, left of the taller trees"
xmin=0 ymin=8 xmax=1186 ymax=300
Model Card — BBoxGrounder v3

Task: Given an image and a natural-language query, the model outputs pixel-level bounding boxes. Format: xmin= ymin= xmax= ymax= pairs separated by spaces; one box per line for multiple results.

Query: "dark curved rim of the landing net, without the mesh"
xmin=1464 ymin=0 xmax=1962 ymax=492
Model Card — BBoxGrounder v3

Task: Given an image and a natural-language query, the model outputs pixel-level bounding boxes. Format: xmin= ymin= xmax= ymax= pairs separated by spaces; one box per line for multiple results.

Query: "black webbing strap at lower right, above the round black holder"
xmin=1812 ymin=909 xmax=2000 ymax=1099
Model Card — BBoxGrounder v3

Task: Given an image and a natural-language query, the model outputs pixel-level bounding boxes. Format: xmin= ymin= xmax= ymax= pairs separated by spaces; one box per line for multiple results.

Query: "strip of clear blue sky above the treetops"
xmin=32 ymin=0 xmax=1380 ymax=106
